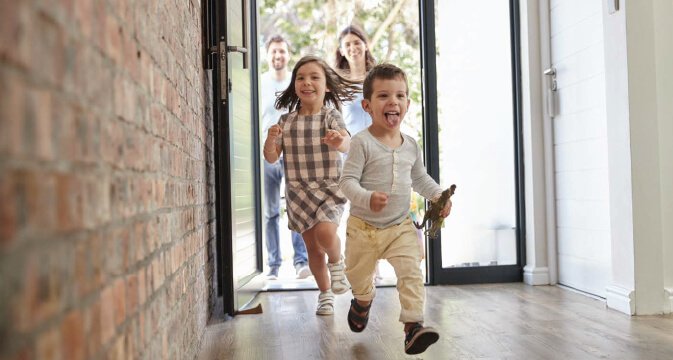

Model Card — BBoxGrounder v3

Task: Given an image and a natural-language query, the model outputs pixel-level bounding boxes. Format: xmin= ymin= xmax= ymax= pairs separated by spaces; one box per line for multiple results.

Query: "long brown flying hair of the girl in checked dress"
xmin=275 ymin=55 xmax=360 ymax=112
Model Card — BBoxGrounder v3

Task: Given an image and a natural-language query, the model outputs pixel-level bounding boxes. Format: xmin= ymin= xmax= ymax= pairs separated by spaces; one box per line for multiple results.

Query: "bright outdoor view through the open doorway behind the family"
xmin=258 ymin=0 xmax=425 ymax=287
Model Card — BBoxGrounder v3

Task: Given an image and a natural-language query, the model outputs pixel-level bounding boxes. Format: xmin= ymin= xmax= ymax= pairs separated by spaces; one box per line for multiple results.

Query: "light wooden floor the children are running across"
xmin=200 ymin=283 xmax=673 ymax=360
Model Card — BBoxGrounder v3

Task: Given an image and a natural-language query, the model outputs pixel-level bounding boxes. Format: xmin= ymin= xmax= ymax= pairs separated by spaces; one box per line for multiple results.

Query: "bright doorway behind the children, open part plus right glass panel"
xmin=257 ymin=0 xmax=525 ymax=290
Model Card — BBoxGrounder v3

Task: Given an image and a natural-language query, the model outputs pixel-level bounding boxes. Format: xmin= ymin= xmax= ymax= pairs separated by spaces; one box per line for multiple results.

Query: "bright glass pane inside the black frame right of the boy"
xmin=435 ymin=0 xmax=517 ymax=268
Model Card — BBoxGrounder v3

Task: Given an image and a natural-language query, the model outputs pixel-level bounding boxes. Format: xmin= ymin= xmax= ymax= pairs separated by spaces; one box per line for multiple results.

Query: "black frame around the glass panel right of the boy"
xmin=419 ymin=0 xmax=526 ymax=285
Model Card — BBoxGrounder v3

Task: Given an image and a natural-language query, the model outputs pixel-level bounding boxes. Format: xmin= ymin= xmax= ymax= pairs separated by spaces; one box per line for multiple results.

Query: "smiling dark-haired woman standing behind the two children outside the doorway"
xmin=334 ymin=25 xmax=376 ymax=136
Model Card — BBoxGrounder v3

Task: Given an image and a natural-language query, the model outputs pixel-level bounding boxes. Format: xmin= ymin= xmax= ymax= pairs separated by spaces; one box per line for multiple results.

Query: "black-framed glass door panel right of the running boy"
xmin=424 ymin=0 xmax=523 ymax=284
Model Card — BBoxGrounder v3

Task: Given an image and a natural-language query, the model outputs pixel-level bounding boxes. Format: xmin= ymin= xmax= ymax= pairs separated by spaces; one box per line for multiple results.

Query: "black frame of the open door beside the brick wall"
xmin=203 ymin=0 xmax=262 ymax=316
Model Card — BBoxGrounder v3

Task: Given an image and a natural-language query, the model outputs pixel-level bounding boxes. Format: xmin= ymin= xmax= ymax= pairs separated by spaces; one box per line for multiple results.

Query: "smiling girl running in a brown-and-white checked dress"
xmin=264 ymin=56 xmax=355 ymax=315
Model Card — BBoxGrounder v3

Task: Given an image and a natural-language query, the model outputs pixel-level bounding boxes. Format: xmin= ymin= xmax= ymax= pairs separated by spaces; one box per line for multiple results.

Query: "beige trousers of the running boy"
xmin=346 ymin=215 xmax=425 ymax=323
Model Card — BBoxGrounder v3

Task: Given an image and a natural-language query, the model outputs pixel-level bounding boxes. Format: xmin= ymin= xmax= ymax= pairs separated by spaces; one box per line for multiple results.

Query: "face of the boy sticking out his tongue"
xmin=362 ymin=78 xmax=410 ymax=130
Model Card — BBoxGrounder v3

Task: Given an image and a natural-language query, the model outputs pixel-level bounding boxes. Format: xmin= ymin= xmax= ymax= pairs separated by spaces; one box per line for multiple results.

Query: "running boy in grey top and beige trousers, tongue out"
xmin=339 ymin=64 xmax=451 ymax=354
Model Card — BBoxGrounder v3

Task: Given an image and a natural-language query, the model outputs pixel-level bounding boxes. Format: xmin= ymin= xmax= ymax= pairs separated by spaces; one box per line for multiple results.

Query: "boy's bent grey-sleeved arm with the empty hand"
xmin=339 ymin=138 xmax=372 ymax=209
